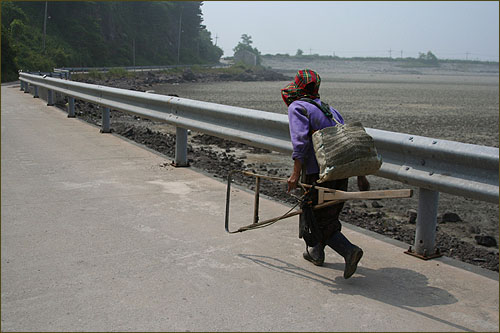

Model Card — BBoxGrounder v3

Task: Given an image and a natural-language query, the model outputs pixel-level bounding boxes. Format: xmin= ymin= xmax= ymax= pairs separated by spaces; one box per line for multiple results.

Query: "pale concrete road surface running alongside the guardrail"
xmin=1 ymin=85 xmax=499 ymax=332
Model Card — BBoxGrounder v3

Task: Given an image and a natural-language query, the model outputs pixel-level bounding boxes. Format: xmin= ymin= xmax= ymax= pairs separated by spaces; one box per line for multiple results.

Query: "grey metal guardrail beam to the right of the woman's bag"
xmin=367 ymin=128 xmax=499 ymax=204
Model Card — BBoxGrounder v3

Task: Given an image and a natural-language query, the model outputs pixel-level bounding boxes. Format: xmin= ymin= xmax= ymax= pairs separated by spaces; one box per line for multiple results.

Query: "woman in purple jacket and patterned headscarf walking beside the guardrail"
xmin=281 ymin=69 xmax=370 ymax=279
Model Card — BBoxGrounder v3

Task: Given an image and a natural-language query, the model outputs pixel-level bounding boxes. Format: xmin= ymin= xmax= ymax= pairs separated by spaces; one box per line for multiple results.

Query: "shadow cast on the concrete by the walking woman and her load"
xmin=239 ymin=254 xmax=471 ymax=331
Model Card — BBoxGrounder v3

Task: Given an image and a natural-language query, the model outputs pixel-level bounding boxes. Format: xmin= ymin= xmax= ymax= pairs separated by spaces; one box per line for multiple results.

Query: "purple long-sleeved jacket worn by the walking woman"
xmin=288 ymin=98 xmax=344 ymax=175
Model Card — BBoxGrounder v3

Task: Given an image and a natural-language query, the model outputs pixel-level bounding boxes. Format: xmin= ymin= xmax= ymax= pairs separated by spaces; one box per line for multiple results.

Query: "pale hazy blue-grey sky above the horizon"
xmin=201 ymin=1 xmax=499 ymax=61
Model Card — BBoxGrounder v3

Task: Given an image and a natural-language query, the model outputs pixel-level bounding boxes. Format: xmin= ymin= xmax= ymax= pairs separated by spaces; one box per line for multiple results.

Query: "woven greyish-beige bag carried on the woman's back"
xmin=312 ymin=122 xmax=382 ymax=183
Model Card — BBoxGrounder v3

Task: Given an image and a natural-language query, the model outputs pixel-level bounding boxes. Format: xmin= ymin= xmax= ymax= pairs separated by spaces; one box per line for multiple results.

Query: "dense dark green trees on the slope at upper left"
xmin=1 ymin=1 xmax=223 ymax=81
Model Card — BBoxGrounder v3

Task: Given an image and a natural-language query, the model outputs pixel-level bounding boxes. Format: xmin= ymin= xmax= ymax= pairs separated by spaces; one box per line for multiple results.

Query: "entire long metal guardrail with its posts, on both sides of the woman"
xmin=19 ymin=73 xmax=499 ymax=259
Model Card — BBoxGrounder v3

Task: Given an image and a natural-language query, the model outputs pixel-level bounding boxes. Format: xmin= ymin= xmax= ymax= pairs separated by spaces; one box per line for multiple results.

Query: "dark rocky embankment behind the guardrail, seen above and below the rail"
xmin=68 ymin=71 xmax=499 ymax=271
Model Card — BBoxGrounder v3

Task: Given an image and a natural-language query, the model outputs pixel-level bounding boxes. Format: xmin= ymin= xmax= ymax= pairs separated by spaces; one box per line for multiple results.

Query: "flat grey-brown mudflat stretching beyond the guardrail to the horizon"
xmin=158 ymin=60 xmax=499 ymax=147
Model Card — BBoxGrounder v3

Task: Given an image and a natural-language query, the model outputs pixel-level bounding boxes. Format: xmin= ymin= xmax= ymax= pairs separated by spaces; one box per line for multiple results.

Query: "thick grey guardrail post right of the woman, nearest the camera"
xmin=415 ymin=188 xmax=440 ymax=259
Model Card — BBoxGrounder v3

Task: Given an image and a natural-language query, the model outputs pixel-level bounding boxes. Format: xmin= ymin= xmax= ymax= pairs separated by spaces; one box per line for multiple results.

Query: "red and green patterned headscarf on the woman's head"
xmin=281 ymin=69 xmax=321 ymax=105
